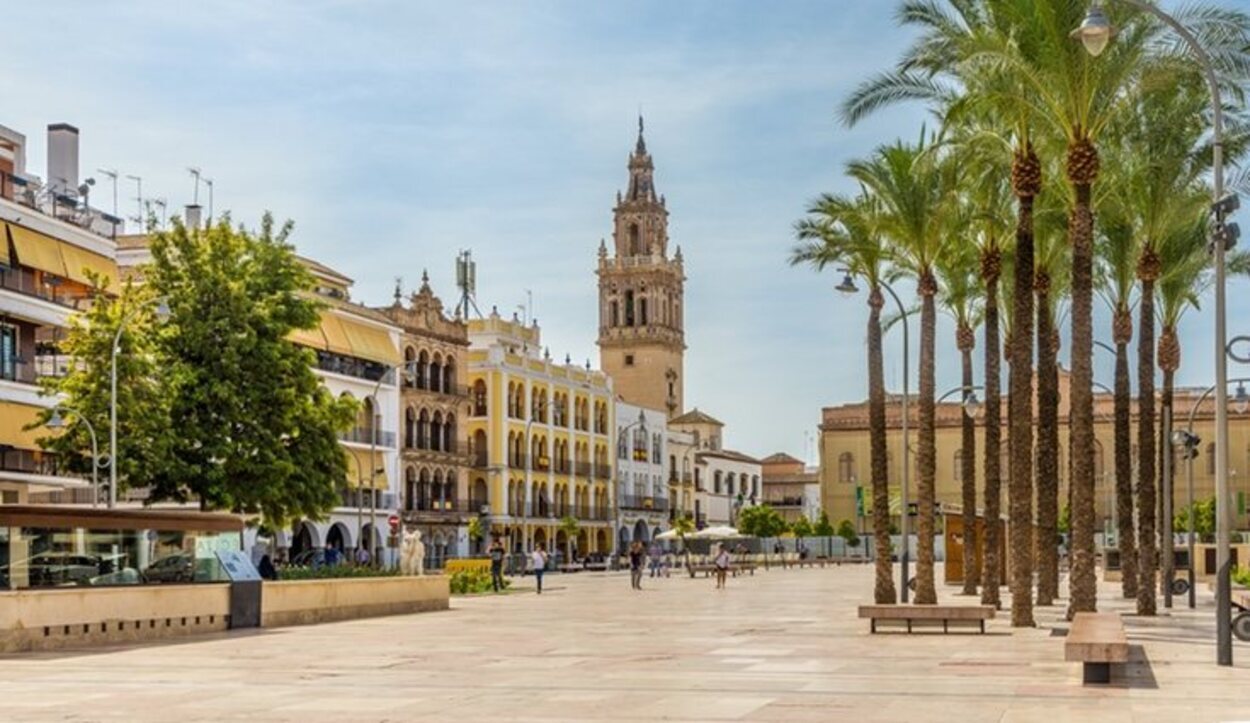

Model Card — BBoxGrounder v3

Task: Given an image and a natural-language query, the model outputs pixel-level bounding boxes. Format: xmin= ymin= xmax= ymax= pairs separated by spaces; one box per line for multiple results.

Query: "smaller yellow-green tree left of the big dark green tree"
xmin=38 ymin=272 xmax=176 ymax=497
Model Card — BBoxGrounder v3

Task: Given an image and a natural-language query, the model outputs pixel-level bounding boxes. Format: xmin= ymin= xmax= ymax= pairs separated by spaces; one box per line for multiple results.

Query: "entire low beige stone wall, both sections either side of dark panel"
xmin=0 ymin=575 xmax=450 ymax=653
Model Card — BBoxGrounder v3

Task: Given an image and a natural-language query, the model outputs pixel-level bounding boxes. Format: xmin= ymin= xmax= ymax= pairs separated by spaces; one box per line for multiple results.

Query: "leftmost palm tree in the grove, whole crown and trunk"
xmin=790 ymin=193 xmax=898 ymax=604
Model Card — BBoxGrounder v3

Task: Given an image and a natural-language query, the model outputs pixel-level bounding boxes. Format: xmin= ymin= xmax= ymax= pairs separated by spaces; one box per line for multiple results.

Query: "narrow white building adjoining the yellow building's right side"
xmin=615 ymin=402 xmax=671 ymax=545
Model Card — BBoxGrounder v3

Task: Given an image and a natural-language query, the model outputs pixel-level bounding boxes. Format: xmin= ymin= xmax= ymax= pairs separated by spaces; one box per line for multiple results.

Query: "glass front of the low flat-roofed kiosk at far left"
xmin=0 ymin=505 xmax=243 ymax=590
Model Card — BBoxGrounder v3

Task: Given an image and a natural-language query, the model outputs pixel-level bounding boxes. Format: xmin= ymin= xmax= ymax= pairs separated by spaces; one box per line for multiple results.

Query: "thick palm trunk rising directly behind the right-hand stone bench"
xmin=1068 ymin=134 xmax=1099 ymax=617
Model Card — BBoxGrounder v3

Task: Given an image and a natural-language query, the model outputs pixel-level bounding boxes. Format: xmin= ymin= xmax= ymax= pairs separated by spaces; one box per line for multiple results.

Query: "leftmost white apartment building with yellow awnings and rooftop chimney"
xmin=0 ymin=124 xmax=123 ymax=504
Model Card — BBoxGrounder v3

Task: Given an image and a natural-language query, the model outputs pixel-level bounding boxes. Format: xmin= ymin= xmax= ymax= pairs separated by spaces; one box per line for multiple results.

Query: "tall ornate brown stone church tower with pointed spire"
xmin=598 ymin=116 xmax=686 ymax=419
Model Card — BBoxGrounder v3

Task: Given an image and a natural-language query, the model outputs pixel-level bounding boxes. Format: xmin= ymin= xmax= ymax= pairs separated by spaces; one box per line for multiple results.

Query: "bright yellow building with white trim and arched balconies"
xmin=468 ymin=311 xmax=615 ymax=554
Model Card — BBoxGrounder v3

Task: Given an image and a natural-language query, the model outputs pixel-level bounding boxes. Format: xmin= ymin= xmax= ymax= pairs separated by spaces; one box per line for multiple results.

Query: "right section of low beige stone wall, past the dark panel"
xmin=260 ymin=575 xmax=450 ymax=628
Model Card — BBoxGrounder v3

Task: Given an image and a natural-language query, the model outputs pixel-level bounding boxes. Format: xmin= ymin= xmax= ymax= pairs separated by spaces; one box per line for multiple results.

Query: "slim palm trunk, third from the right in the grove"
xmin=1111 ymin=306 xmax=1138 ymax=599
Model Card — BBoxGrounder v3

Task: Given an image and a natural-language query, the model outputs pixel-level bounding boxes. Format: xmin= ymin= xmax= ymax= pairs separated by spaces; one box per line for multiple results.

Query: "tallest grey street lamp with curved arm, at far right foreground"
xmin=1071 ymin=0 xmax=1239 ymax=665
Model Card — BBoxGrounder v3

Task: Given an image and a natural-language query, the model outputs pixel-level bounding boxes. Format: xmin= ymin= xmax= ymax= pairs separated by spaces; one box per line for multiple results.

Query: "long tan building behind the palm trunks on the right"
xmin=820 ymin=372 xmax=1250 ymax=529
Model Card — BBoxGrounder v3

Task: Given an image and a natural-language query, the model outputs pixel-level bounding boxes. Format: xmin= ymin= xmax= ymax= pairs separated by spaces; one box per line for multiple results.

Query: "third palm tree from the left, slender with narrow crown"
xmin=936 ymin=236 xmax=983 ymax=595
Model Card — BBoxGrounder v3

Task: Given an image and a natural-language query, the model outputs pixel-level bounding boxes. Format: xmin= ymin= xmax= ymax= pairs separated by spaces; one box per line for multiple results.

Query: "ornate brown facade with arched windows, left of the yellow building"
xmin=380 ymin=274 xmax=470 ymax=568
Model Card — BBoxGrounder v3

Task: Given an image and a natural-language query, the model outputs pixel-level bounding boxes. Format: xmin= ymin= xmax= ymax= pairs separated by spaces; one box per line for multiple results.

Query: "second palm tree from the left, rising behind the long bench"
xmin=848 ymin=138 xmax=955 ymax=604
